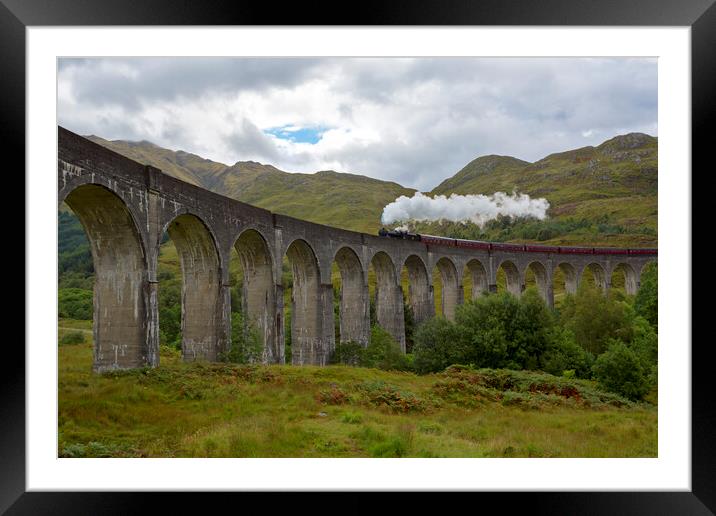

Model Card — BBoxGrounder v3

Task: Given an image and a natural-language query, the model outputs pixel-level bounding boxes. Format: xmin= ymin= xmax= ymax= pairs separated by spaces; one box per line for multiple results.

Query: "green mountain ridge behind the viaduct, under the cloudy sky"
xmin=88 ymin=133 xmax=658 ymax=245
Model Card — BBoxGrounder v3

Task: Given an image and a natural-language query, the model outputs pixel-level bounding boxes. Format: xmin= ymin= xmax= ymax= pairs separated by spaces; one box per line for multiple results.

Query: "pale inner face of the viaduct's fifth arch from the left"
xmin=335 ymin=247 xmax=370 ymax=347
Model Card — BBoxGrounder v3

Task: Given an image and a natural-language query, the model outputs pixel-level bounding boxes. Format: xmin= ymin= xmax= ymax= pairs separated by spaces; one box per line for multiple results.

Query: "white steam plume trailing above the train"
xmin=380 ymin=192 xmax=549 ymax=226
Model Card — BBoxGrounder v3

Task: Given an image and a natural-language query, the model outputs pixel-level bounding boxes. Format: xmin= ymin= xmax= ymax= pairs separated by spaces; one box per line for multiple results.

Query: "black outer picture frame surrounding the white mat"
xmin=5 ymin=0 xmax=716 ymax=515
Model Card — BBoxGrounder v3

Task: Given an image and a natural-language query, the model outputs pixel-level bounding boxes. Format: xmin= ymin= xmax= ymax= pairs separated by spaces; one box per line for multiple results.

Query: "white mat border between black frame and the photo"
xmin=25 ymin=27 xmax=691 ymax=491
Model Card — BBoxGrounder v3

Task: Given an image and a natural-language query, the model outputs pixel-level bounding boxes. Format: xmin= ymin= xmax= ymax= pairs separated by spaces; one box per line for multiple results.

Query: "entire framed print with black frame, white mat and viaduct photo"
xmin=7 ymin=0 xmax=716 ymax=514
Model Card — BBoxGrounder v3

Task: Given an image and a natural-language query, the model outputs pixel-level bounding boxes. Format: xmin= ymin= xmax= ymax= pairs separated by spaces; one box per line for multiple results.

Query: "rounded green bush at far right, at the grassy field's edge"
xmin=592 ymin=340 xmax=652 ymax=400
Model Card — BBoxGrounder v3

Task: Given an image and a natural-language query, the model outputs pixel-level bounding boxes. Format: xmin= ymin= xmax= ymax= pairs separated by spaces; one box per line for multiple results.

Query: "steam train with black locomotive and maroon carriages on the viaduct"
xmin=378 ymin=228 xmax=657 ymax=255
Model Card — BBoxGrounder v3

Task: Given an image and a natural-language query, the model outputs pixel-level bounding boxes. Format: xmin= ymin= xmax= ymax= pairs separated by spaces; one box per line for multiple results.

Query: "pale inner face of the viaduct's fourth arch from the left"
xmin=286 ymin=239 xmax=326 ymax=365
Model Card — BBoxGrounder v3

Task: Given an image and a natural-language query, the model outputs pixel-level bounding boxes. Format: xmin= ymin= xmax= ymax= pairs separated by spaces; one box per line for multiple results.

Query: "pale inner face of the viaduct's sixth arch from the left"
xmin=370 ymin=251 xmax=405 ymax=352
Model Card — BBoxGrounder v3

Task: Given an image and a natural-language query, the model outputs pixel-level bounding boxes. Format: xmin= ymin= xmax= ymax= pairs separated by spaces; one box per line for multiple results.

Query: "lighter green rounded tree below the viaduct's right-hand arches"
xmin=561 ymin=281 xmax=633 ymax=355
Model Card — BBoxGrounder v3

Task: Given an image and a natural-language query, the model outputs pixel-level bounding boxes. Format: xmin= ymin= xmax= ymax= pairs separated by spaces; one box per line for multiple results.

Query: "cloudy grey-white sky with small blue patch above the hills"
xmin=58 ymin=58 xmax=657 ymax=190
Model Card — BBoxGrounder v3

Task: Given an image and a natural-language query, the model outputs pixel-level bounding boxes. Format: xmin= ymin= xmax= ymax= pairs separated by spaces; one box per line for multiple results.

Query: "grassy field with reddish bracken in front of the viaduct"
xmin=58 ymin=340 xmax=657 ymax=457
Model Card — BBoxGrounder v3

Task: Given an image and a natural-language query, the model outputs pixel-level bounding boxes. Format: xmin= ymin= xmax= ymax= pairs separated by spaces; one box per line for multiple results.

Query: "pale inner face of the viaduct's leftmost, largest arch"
xmin=64 ymin=184 xmax=152 ymax=372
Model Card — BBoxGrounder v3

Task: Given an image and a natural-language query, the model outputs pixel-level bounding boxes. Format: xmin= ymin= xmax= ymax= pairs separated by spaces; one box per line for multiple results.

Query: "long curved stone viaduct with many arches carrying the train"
xmin=57 ymin=127 xmax=656 ymax=372
